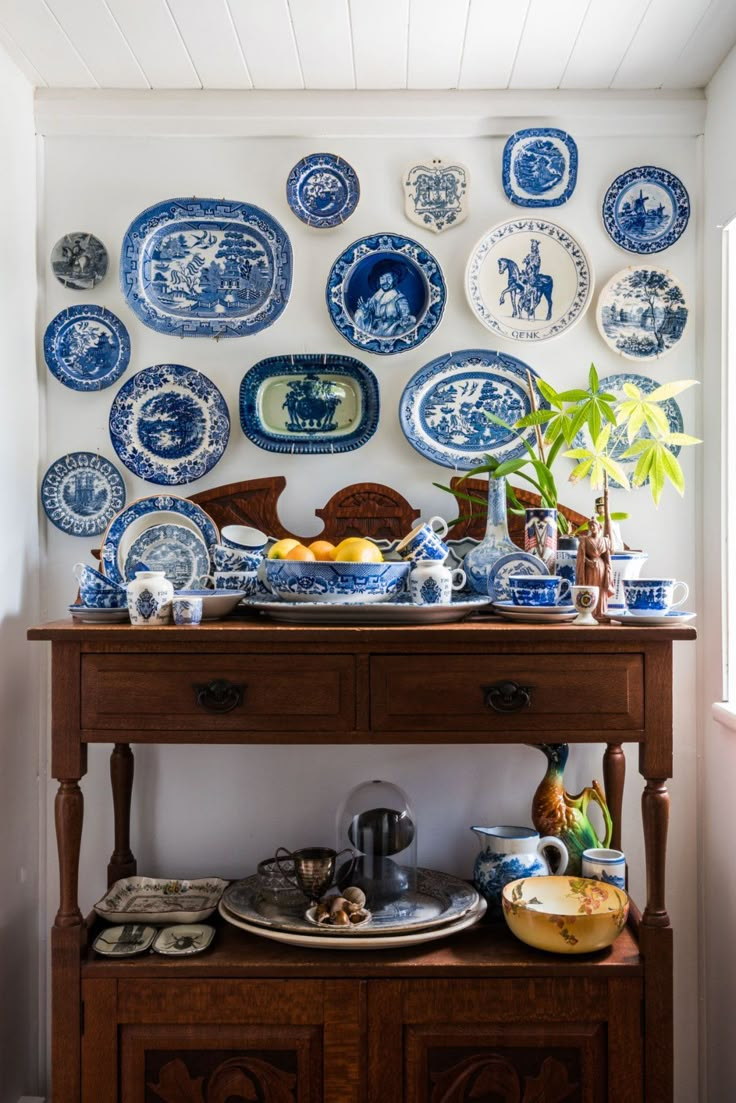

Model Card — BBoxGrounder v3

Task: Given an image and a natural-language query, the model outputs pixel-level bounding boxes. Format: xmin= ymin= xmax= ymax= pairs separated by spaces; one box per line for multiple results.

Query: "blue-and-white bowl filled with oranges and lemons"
xmin=265 ymin=559 xmax=410 ymax=604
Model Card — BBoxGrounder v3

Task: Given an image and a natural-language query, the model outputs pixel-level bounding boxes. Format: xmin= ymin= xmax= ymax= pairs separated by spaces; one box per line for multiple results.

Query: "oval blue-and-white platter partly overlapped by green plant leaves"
xmin=398 ymin=349 xmax=547 ymax=471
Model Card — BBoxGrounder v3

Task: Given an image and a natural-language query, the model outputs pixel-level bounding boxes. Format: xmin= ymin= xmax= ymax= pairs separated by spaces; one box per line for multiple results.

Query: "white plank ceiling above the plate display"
xmin=0 ymin=0 xmax=736 ymax=89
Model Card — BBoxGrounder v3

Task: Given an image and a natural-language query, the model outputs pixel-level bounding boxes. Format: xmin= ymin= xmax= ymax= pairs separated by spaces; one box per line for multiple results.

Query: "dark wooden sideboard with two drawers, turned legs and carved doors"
xmin=29 ymin=620 xmax=695 ymax=1103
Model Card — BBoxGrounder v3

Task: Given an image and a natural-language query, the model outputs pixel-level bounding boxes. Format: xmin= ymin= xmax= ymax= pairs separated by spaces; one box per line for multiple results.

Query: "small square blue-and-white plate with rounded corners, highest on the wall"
xmin=503 ymin=127 xmax=577 ymax=207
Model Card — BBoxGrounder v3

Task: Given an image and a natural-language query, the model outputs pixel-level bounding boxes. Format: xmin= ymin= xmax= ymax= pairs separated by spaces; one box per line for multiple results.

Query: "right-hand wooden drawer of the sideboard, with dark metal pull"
xmin=371 ymin=653 xmax=644 ymax=741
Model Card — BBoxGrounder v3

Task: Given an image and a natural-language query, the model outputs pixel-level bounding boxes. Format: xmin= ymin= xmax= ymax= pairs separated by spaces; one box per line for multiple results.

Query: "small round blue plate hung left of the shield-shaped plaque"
xmin=286 ymin=153 xmax=361 ymax=229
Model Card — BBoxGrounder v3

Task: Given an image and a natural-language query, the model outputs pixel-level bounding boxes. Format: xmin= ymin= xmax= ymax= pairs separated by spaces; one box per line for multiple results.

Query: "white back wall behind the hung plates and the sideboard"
xmin=40 ymin=94 xmax=701 ymax=1103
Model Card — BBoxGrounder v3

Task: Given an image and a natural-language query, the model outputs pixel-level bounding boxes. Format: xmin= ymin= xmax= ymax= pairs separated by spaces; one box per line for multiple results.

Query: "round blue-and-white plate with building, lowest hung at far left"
xmin=41 ymin=452 xmax=126 ymax=536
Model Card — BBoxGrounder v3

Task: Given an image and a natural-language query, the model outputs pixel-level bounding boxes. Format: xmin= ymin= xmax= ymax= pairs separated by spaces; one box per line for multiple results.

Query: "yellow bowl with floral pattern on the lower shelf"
xmin=502 ymin=877 xmax=629 ymax=954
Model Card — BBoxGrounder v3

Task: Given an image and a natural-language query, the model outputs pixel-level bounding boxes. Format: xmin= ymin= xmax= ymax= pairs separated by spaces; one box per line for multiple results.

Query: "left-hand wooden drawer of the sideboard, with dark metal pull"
xmin=82 ymin=652 xmax=355 ymax=733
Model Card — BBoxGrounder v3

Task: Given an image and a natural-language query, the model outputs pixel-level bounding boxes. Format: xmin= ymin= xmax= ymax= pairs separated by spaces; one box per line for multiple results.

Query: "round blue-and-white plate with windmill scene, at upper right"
xmin=602 ymin=164 xmax=690 ymax=254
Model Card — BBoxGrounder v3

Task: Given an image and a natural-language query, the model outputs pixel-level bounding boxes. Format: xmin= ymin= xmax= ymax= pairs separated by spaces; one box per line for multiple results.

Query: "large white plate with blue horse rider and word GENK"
xmin=466 ymin=218 xmax=593 ymax=341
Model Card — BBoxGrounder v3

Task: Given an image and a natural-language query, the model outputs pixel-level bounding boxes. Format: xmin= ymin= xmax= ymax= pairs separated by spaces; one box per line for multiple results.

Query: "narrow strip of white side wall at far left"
xmin=0 ymin=53 xmax=45 ymax=1103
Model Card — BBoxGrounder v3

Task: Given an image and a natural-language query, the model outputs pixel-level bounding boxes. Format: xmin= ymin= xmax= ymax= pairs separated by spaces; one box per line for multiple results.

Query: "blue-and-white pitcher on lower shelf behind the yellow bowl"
xmin=470 ymin=827 xmax=567 ymax=919
